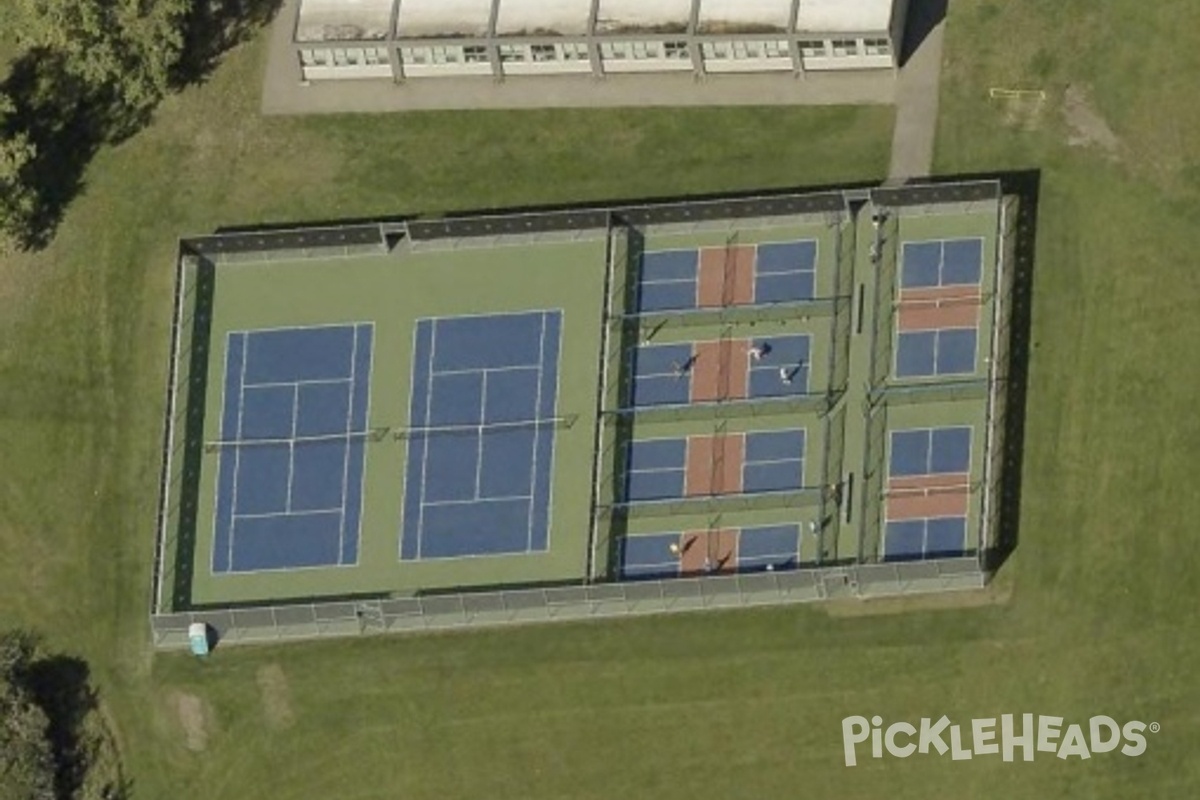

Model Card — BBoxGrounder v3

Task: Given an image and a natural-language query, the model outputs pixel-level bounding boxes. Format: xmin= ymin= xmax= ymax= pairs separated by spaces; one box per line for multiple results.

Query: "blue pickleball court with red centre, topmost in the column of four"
xmin=635 ymin=240 xmax=817 ymax=313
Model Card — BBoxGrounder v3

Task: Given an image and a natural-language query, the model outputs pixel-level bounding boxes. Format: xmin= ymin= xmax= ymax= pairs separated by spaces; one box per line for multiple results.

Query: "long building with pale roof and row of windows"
xmin=292 ymin=0 xmax=908 ymax=82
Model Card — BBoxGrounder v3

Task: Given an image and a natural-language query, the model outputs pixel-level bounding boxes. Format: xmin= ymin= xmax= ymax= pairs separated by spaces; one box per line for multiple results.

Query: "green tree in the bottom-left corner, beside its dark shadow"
xmin=0 ymin=633 xmax=55 ymax=800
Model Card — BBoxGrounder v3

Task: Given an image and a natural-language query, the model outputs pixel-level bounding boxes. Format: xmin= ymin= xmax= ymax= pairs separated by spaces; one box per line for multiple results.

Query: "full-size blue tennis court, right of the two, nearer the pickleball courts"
xmin=401 ymin=311 xmax=563 ymax=560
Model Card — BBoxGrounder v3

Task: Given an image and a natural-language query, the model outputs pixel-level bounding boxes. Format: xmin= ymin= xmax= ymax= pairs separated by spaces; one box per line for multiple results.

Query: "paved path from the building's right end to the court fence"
xmin=888 ymin=1 xmax=946 ymax=184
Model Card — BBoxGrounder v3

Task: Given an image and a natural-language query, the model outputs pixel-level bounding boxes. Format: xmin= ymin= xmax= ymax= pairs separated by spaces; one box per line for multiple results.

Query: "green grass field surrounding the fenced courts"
xmin=0 ymin=0 xmax=1200 ymax=800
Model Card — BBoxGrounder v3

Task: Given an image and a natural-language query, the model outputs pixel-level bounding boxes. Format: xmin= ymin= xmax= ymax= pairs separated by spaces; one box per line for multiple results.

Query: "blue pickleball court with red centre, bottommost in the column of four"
xmin=619 ymin=524 xmax=800 ymax=579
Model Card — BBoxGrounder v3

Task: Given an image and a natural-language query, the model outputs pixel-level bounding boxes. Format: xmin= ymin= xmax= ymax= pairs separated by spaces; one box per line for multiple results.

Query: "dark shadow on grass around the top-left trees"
xmin=0 ymin=0 xmax=281 ymax=249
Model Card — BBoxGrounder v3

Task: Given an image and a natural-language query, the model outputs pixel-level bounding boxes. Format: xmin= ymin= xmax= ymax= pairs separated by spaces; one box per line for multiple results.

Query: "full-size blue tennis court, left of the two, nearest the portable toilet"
xmin=212 ymin=324 xmax=373 ymax=573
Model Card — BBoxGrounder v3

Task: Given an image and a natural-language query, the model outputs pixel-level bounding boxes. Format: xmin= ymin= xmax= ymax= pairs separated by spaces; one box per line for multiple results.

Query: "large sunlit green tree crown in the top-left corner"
xmin=18 ymin=0 xmax=188 ymax=112
